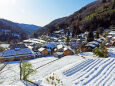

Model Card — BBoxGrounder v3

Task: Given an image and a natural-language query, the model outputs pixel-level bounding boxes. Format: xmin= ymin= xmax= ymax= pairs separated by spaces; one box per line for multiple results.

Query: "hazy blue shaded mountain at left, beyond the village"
xmin=0 ymin=19 xmax=41 ymax=41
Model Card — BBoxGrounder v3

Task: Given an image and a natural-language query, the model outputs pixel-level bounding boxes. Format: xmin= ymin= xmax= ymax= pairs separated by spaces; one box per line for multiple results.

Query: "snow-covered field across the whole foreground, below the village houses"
xmin=0 ymin=48 xmax=115 ymax=86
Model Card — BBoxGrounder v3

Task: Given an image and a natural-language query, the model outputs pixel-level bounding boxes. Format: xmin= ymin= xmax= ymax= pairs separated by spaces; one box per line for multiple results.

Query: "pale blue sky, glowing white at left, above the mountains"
xmin=0 ymin=0 xmax=95 ymax=26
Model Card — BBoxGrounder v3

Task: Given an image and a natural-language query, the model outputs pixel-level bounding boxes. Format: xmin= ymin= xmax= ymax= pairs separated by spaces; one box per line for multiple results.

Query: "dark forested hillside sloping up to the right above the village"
xmin=34 ymin=0 xmax=115 ymax=35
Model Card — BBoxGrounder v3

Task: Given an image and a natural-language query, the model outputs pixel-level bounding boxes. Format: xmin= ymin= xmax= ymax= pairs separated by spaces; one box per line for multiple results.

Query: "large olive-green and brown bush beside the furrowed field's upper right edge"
xmin=93 ymin=44 xmax=109 ymax=58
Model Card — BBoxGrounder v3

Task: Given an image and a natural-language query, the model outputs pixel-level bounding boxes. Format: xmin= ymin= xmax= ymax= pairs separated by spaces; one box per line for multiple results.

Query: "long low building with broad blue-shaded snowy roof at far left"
xmin=0 ymin=48 xmax=35 ymax=60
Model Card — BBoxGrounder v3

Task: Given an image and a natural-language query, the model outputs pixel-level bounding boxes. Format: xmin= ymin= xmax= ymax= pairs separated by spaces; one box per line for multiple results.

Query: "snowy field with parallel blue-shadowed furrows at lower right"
xmin=63 ymin=58 xmax=115 ymax=86
